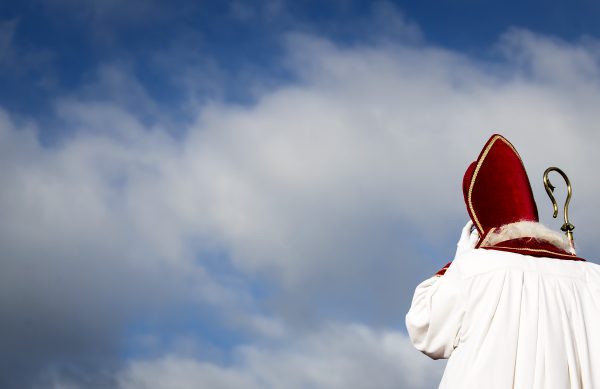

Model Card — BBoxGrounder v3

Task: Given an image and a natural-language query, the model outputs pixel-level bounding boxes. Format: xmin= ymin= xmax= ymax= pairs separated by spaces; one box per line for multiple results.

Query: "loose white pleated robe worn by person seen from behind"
xmin=406 ymin=249 xmax=600 ymax=389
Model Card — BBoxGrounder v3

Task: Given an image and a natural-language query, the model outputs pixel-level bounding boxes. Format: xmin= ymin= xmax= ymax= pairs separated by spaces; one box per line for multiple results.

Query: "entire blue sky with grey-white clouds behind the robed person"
xmin=0 ymin=0 xmax=600 ymax=389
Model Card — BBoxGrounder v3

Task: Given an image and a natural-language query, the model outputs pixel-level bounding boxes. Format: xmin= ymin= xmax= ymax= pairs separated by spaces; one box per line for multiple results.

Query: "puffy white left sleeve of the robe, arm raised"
xmin=406 ymin=266 xmax=464 ymax=359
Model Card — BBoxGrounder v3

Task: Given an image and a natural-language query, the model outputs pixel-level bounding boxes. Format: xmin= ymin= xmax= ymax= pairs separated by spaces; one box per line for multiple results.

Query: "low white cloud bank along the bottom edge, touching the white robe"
xmin=119 ymin=323 xmax=442 ymax=389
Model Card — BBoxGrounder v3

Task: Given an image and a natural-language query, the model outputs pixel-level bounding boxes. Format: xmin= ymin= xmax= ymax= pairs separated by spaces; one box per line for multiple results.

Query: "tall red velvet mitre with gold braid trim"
xmin=463 ymin=134 xmax=539 ymax=242
